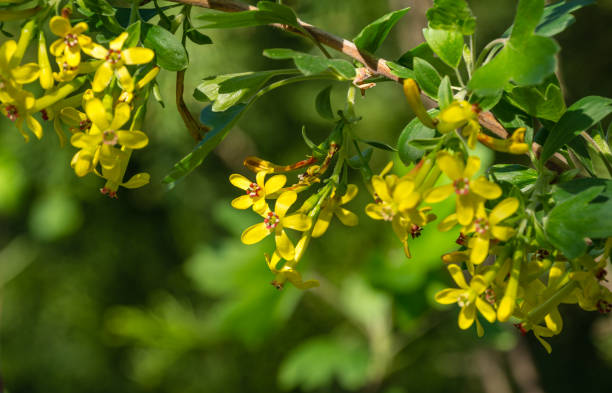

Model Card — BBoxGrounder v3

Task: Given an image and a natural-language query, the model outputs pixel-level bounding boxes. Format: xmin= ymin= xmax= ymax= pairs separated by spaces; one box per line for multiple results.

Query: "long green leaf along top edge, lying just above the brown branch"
xmin=197 ymin=1 xmax=299 ymax=29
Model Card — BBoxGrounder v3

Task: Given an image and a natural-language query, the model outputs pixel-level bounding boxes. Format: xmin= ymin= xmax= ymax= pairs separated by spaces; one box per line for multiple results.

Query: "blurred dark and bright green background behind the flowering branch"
xmin=0 ymin=0 xmax=612 ymax=393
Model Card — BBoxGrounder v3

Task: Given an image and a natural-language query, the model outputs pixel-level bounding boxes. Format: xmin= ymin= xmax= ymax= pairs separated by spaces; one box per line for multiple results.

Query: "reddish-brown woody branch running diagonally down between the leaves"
xmin=171 ymin=0 xmax=569 ymax=172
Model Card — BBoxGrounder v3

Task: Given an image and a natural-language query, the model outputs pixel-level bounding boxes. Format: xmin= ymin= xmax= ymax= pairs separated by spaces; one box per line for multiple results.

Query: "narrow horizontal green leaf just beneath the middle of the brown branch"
xmin=263 ymin=48 xmax=355 ymax=79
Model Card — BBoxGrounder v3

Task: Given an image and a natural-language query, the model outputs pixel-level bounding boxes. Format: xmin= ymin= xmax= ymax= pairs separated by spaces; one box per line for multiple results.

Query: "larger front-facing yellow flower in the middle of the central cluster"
xmin=241 ymin=191 xmax=312 ymax=261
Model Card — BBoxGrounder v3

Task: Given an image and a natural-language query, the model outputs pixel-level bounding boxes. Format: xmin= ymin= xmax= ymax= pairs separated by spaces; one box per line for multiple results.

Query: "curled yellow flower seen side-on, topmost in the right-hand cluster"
xmin=436 ymin=101 xmax=480 ymax=149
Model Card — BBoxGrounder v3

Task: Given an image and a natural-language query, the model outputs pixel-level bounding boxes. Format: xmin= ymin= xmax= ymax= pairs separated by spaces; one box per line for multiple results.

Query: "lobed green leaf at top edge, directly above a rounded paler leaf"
xmin=427 ymin=0 xmax=476 ymax=35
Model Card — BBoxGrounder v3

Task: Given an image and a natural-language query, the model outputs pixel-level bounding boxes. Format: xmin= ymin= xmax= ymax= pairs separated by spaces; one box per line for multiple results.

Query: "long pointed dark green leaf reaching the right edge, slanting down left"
xmin=540 ymin=96 xmax=612 ymax=164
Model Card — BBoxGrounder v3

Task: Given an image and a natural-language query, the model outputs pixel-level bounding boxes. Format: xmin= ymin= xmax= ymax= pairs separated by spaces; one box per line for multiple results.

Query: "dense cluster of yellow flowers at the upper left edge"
xmin=0 ymin=16 xmax=159 ymax=197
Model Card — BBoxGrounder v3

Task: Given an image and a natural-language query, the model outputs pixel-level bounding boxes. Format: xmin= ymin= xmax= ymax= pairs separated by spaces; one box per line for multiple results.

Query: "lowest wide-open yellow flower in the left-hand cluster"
xmin=70 ymin=98 xmax=149 ymax=176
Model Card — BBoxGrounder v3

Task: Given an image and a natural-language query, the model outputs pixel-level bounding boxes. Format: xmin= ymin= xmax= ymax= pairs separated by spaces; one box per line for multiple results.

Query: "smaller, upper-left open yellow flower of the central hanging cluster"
xmin=230 ymin=172 xmax=287 ymax=214
